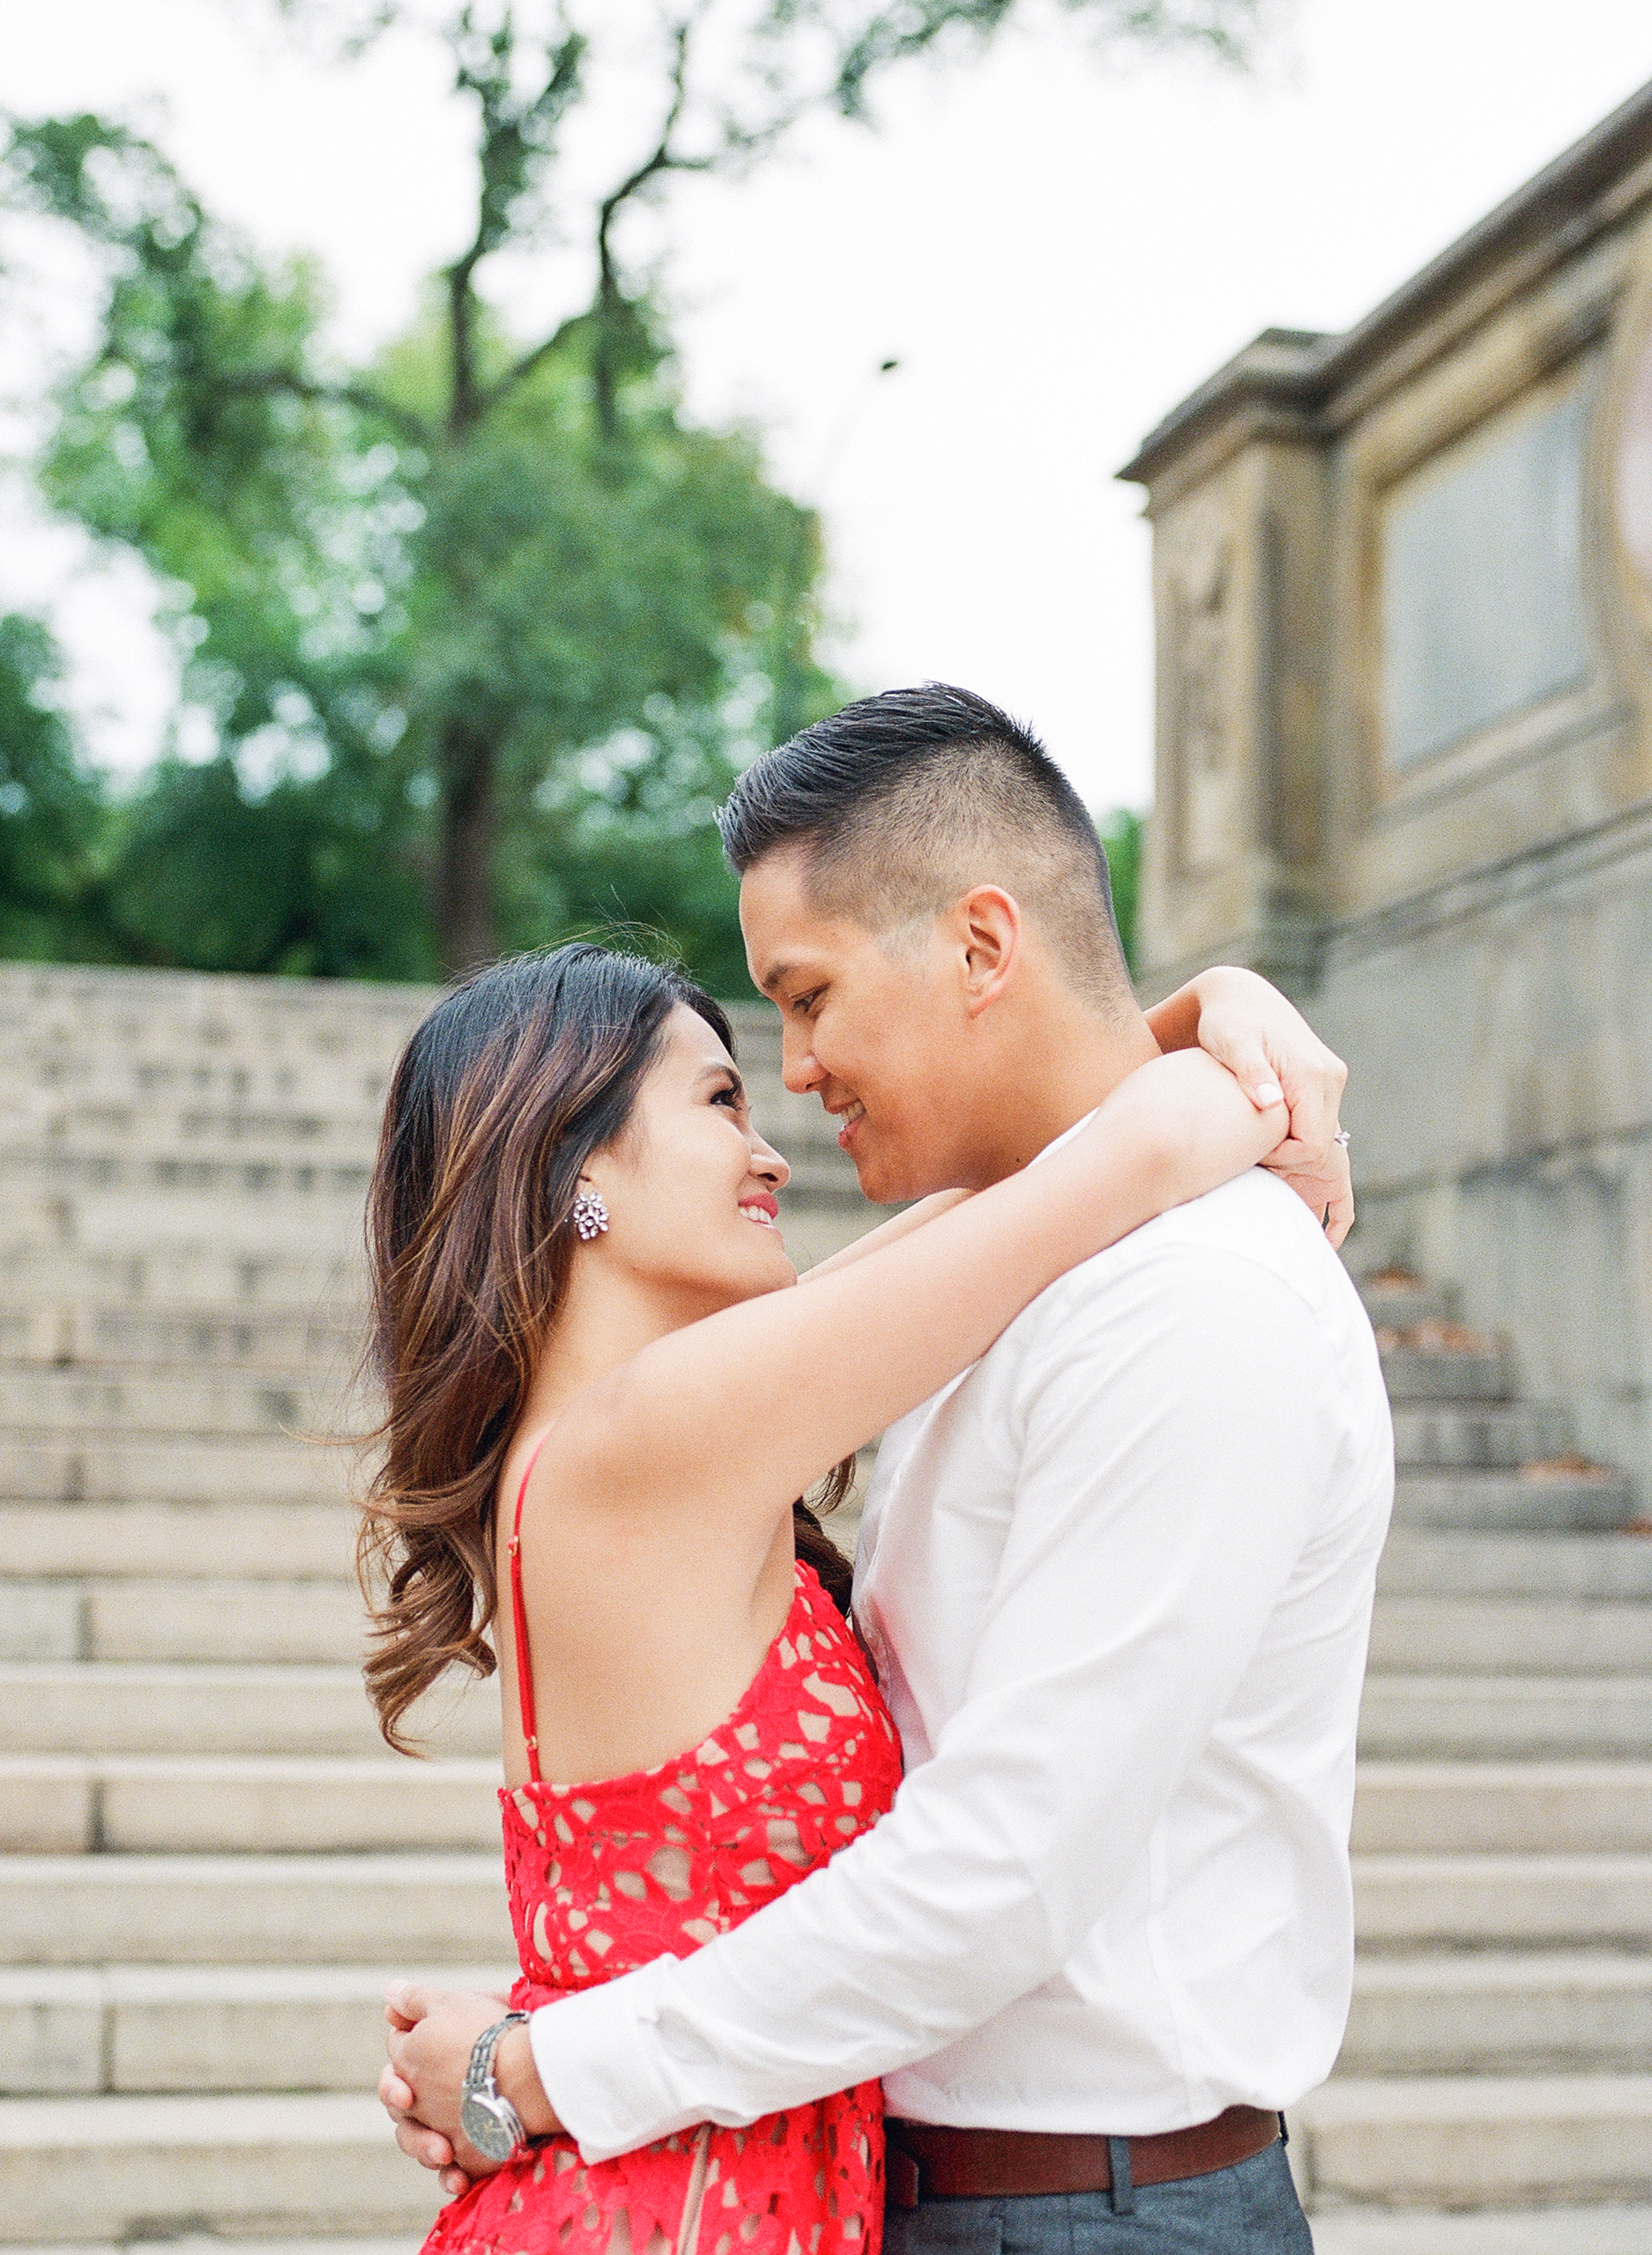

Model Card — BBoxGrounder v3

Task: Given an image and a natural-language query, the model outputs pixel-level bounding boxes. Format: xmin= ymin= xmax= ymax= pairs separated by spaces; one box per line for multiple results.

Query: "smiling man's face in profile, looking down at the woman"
xmin=740 ymin=850 xmax=973 ymax=1204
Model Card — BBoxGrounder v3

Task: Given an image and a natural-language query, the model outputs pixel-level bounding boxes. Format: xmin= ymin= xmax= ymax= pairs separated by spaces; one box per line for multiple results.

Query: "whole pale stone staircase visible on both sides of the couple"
xmin=0 ymin=965 xmax=1652 ymax=2255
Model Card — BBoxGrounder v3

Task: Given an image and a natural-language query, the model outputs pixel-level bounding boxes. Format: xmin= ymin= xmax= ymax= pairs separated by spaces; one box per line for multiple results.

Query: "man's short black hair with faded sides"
xmin=717 ymin=681 xmax=1131 ymax=1006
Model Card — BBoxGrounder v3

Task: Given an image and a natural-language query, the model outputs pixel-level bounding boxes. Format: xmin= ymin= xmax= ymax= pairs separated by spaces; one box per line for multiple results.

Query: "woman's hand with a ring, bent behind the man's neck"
xmin=1147 ymin=965 xmax=1355 ymax=1245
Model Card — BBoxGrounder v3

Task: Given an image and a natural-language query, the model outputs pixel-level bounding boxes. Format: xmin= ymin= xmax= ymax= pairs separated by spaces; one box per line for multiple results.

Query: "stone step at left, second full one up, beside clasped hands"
xmin=0 ymin=1964 xmax=516 ymax=2097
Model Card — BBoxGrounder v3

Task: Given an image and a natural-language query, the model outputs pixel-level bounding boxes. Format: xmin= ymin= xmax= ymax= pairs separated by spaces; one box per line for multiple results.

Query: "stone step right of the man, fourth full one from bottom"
xmin=1355 ymin=1761 xmax=1652 ymax=1856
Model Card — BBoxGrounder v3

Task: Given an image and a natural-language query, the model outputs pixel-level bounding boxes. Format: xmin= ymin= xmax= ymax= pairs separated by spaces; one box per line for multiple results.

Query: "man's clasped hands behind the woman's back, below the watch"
xmin=379 ymin=1982 xmax=562 ymax=2194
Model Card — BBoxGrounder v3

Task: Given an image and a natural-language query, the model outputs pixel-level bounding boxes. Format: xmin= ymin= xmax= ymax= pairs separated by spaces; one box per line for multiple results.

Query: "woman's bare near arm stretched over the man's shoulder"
xmin=561 ymin=1053 xmax=1284 ymax=1524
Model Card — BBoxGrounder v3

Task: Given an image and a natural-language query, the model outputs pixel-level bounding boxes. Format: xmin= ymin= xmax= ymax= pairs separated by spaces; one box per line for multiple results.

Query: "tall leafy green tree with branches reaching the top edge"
xmin=7 ymin=0 xmax=1255 ymax=971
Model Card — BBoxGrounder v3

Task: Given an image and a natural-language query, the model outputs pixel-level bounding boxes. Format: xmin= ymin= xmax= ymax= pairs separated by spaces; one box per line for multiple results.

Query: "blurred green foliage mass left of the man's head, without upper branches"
xmin=13 ymin=120 xmax=837 ymax=993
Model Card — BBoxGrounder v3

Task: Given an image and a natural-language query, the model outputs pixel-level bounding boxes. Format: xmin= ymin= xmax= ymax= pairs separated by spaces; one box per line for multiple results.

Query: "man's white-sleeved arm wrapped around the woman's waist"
xmin=509 ymin=1245 xmax=1328 ymax=2161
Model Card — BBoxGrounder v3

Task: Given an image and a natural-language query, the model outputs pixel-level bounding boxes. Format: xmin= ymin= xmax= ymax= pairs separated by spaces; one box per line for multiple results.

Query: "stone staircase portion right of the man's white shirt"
xmin=1293 ymin=1272 xmax=1652 ymax=2255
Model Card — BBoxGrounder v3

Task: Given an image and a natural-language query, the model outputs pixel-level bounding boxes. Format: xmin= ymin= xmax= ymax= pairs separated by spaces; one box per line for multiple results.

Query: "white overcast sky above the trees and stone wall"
xmin=0 ymin=0 xmax=1652 ymax=807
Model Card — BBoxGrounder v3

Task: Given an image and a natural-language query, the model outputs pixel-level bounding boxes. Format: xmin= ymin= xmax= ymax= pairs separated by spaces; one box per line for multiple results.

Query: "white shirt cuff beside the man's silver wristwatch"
xmin=527 ymin=1957 xmax=705 ymax=2161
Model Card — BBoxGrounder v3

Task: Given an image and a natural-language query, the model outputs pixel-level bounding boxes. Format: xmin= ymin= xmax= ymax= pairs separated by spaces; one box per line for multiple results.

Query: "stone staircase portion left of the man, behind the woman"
xmin=0 ymin=965 xmax=863 ymax=2246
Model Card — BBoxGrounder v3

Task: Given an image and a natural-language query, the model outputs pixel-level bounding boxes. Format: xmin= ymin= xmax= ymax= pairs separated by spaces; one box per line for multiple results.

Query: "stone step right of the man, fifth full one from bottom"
xmin=1359 ymin=1676 xmax=1652 ymax=1761
